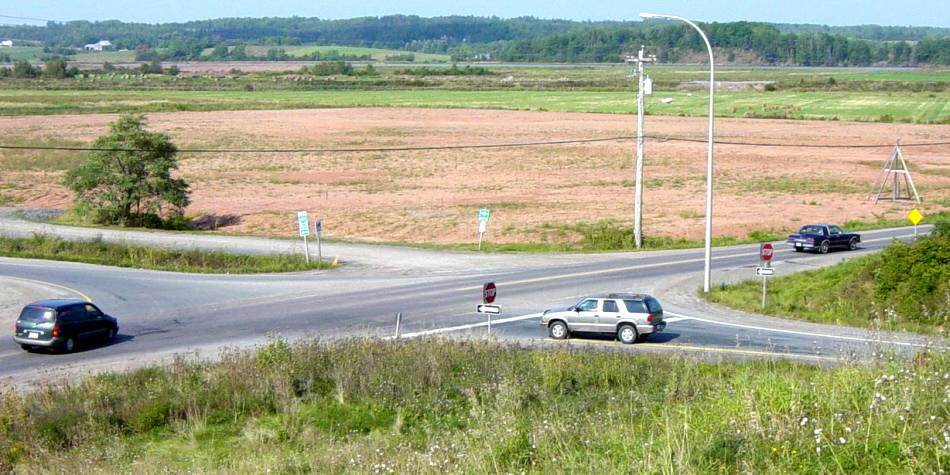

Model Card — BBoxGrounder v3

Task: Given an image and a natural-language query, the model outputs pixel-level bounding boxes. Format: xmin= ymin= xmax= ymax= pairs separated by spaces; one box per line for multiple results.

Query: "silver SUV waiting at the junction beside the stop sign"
xmin=541 ymin=293 xmax=666 ymax=344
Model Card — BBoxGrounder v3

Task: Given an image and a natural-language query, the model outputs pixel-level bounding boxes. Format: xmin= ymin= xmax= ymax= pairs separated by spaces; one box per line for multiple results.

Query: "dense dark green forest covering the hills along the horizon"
xmin=0 ymin=15 xmax=950 ymax=66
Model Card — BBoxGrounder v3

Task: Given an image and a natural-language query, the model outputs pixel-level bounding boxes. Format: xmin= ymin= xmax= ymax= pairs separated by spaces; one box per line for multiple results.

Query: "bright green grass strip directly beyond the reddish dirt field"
xmin=0 ymin=89 xmax=950 ymax=123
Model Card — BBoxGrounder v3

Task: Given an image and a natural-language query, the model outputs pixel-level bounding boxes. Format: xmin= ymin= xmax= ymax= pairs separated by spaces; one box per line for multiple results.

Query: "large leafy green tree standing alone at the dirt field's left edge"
xmin=64 ymin=114 xmax=190 ymax=227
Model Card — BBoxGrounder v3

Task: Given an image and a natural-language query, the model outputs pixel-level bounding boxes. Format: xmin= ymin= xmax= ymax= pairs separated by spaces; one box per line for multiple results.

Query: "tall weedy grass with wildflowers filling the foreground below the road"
xmin=0 ymin=340 xmax=950 ymax=473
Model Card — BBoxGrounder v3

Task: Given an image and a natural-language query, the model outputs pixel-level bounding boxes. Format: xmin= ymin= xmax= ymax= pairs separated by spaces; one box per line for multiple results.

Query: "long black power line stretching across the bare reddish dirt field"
xmin=0 ymin=135 xmax=950 ymax=153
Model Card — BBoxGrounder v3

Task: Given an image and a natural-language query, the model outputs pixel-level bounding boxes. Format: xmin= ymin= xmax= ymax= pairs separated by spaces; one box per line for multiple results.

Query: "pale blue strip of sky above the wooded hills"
xmin=0 ymin=0 xmax=950 ymax=27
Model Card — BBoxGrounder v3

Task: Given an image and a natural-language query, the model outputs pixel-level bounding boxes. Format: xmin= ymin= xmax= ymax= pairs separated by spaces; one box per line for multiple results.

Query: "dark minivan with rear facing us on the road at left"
xmin=13 ymin=299 xmax=119 ymax=353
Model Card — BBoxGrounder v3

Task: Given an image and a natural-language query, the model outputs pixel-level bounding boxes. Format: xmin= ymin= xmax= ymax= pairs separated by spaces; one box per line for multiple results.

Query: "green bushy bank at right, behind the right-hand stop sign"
xmin=706 ymin=222 xmax=950 ymax=334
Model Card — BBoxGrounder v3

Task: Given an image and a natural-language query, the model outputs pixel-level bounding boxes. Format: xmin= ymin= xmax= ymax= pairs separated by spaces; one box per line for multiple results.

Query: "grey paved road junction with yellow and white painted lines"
xmin=0 ymin=222 xmax=940 ymax=380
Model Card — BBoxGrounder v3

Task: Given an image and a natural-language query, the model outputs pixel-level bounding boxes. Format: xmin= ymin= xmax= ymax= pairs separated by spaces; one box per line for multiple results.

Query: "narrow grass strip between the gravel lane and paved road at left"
xmin=0 ymin=235 xmax=332 ymax=274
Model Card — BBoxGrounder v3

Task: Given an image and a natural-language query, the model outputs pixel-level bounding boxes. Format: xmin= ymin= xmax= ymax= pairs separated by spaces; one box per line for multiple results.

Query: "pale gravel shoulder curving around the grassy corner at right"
xmin=653 ymin=247 xmax=947 ymax=350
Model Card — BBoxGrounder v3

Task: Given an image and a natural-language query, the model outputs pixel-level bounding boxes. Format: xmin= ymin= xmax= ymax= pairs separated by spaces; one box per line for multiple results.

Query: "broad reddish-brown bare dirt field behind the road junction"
xmin=0 ymin=109 xmax=950 ymax=243
